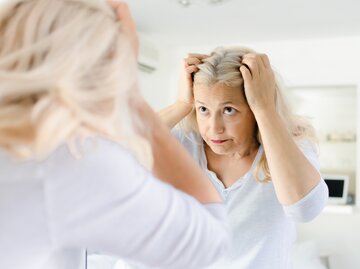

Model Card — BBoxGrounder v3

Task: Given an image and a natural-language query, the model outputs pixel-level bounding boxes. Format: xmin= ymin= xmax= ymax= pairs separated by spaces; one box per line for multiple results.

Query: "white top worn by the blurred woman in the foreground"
xmin=0 ymin=138 xmax=229 ymax=269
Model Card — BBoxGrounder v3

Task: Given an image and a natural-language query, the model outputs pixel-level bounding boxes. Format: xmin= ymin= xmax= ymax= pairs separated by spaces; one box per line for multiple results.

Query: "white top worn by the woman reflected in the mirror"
xmin=172 ymin=129 xmax=328 ymax=269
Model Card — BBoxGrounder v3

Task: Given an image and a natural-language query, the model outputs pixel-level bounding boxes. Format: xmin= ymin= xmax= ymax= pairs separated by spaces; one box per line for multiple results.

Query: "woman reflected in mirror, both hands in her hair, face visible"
xmin=160 ymin=48 xmax=328 ymax=269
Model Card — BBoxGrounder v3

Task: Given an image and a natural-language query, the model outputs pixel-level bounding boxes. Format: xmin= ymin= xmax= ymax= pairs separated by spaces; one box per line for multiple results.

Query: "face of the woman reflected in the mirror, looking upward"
xmin=194 ymin=83 xmax=256 ymax=155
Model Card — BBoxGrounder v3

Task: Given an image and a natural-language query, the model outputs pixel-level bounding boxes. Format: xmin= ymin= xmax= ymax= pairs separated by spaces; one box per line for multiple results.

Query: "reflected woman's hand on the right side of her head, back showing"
xmin=240 ymin=53 xmax=276 ymax=115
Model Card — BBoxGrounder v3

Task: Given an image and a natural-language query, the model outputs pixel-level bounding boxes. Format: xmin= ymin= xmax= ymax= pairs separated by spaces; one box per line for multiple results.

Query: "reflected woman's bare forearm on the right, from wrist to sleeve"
xmin=255 ymin=110 xmax=321 ymax=205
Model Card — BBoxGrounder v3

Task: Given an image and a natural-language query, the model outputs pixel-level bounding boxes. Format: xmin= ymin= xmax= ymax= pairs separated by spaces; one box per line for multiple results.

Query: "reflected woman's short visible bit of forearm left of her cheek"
xmin=158 ymin=102 xmax=193 ymax=129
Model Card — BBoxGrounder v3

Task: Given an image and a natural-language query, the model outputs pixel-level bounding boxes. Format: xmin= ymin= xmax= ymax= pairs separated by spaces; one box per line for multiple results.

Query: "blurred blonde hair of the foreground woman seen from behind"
xmin=0 ymin=0 xmax=152 ymax=167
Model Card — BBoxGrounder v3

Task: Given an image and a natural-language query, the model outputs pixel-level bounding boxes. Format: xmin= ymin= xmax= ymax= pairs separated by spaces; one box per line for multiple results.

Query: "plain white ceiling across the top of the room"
xmin=126 ymin=0 xmax=360 ymax=45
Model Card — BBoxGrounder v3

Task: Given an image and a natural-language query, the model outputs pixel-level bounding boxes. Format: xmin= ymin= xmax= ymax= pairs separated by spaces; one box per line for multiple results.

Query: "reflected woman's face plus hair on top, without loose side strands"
xmin=194 ymin=48 xmax=257 ymax=155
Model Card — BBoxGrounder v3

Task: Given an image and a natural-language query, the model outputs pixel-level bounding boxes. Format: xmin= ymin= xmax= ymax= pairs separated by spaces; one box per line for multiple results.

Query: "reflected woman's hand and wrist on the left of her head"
xmin=176 ymin=54 xmax=208 ymax=108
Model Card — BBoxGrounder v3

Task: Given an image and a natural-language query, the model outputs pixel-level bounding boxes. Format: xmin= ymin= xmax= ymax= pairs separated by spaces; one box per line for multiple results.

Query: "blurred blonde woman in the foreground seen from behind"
xmin=0 ymin=0 xmax=229 ymax=269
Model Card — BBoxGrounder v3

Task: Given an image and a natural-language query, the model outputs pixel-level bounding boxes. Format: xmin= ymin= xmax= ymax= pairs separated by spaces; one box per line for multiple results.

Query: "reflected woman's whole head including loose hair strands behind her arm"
xmin=183 ymin=47 xmax=314 ymax=178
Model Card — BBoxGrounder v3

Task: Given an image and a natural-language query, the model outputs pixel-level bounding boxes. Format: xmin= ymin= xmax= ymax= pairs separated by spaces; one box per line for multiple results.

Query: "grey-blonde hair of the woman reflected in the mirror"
xmin=180 ymin=47 xmax=316 ymax=182
